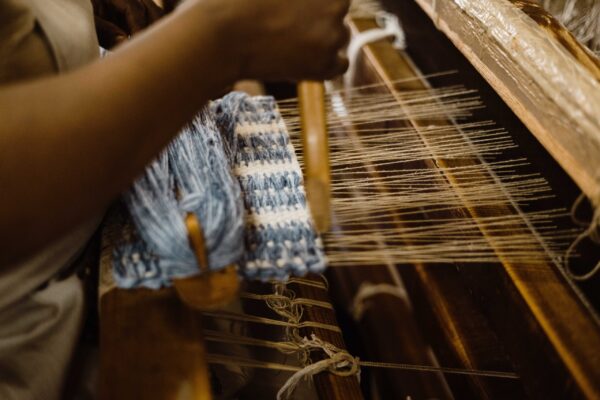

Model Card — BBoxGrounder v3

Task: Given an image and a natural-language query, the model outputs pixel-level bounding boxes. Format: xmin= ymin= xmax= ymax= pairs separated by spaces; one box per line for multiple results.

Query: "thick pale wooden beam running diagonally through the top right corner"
xmin=408 ymin=0 xmax=600 ymax=206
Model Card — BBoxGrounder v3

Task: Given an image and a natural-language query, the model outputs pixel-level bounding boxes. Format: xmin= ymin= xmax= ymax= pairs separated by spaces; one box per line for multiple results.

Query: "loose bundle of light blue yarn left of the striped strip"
xmin=113 ymin=113 xmax=243 ymax=289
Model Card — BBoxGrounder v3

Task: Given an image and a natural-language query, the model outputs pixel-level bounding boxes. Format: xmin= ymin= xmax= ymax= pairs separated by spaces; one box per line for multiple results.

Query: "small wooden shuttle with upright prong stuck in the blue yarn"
xmin=173 ymin=213 xmax=240 ymax=310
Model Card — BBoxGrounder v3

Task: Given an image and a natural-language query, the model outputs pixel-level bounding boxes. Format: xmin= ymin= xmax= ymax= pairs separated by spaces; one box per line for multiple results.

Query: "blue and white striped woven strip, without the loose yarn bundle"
xmin=211 ymin=93 xmax=325 ymax=280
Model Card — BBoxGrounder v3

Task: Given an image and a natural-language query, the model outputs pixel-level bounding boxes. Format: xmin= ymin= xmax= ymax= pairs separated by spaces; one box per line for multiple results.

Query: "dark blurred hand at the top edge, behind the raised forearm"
xmin=92 ymin=0 xmax=166 ymax=49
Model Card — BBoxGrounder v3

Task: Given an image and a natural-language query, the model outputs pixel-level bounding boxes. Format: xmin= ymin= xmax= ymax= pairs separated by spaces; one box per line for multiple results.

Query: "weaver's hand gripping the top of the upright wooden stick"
xmin=229 ymin=0 xmax=349 ymax=80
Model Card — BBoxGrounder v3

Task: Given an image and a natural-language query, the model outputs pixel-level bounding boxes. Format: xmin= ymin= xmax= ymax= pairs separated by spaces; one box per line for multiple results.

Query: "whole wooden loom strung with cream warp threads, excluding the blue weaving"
xmin=100 ymin=0 xmax=600 ymax=399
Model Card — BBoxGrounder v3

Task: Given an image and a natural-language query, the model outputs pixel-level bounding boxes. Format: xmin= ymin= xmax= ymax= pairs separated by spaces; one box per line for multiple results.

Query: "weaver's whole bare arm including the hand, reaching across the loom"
xmin=0 ymin=0 xmax=347 ymax=265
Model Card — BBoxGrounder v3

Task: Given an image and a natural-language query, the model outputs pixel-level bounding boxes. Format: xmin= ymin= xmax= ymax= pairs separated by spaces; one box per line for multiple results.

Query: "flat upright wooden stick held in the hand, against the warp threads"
xmin=298 ymin=81 xmax=331 ymax=232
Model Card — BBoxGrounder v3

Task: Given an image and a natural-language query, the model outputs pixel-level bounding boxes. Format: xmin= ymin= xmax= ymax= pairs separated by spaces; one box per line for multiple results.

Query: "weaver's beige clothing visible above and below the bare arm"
xmin=0 ymin=0 xmax=98 ymax=400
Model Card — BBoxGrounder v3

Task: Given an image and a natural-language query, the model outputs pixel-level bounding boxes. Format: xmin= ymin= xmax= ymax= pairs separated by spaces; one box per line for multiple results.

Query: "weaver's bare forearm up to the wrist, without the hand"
xmin=0 ymin=1 xmax=237 ymax=265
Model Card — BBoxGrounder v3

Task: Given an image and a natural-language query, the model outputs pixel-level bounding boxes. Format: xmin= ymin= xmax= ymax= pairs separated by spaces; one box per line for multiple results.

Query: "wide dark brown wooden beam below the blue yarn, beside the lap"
xmin=99 ymin=289 xmax=211 ymax=400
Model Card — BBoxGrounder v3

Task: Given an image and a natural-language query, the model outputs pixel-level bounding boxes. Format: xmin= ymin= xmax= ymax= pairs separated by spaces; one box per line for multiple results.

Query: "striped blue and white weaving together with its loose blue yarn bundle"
xmin=113 ymin=93 xmax=325 ymax=288
